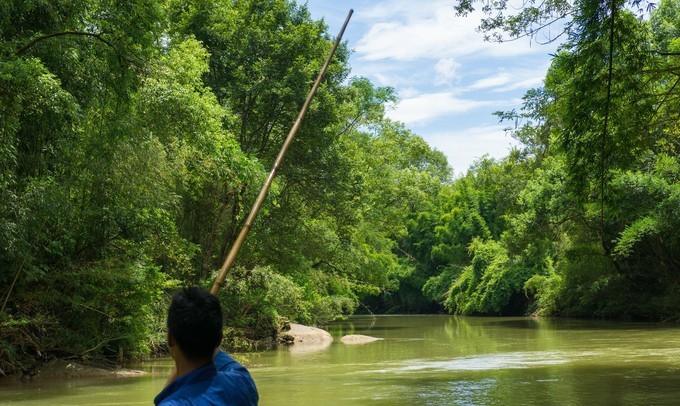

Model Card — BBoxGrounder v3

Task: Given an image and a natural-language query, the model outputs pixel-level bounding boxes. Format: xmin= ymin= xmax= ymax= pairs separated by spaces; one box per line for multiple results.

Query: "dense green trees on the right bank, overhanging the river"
xmin=386 ymin=0 xmax=680 ymax=320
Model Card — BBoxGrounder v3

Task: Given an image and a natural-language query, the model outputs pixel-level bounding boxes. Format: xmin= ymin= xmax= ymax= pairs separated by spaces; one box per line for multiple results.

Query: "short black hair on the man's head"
xmin=168 ymin=287 xmax=222 ymax=360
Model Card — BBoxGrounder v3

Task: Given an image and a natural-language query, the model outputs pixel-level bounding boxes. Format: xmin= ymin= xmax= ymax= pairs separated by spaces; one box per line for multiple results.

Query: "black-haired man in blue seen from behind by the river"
xmin=154 ymin=288 xmax=258 ymax=406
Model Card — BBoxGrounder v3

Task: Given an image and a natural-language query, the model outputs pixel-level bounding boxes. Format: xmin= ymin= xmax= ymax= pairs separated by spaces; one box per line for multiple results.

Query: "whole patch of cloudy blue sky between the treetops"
xmin=300 ymin=0 xmax=555 ymax=175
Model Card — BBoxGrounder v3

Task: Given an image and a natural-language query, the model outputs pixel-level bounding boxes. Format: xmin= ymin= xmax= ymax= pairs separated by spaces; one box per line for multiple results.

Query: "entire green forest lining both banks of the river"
xmin=0 ymin=0 xmax=680 ymax=373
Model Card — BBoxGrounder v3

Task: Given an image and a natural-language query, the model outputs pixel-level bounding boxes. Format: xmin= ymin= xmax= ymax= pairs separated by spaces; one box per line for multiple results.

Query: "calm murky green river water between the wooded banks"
xmin=0 ymin=316 xmax=680 ymax=406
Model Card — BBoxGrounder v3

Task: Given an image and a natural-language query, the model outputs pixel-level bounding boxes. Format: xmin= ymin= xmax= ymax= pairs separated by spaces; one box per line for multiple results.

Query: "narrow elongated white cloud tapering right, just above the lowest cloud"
xmin=387 ymin=92 xmax=498 ymax=124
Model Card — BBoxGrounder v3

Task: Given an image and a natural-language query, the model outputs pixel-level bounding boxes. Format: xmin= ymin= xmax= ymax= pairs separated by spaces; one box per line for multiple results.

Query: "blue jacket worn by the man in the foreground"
xmin=154 ymin=351 xmax=259 ymax=406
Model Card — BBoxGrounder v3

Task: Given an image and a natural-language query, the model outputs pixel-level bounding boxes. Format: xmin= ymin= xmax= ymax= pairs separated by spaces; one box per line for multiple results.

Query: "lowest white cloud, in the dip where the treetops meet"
xmin=420 ymin=125 xmax=518 ymax=175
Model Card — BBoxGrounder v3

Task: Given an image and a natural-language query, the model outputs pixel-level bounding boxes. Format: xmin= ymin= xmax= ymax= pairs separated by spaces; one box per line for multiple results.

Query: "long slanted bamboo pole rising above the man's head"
xmin=210 ymin=9 xmax=354 ymax=295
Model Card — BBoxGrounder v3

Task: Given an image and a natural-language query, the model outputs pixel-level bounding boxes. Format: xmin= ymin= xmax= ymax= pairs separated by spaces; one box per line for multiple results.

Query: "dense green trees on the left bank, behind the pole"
xmin=0 ymin=0 xmax=449 ymax=374
